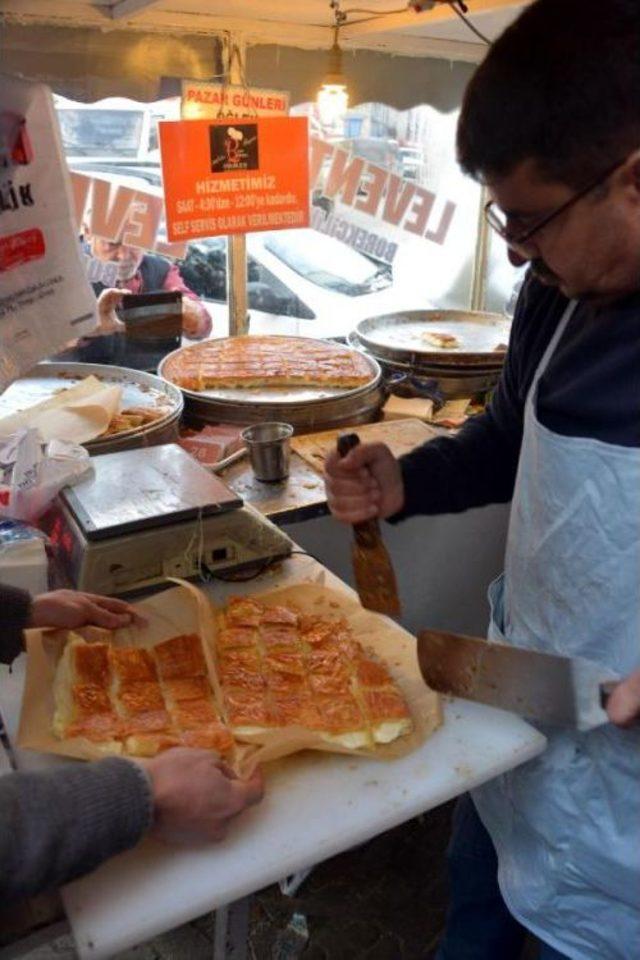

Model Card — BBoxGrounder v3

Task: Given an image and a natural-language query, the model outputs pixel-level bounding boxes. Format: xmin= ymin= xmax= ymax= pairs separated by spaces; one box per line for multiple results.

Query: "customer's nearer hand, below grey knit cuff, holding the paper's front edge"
xmin=138 ymin=747 xmax=263 ymax=844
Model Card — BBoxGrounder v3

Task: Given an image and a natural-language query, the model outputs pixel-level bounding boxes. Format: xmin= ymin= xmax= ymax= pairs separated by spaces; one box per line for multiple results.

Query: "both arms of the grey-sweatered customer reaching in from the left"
xmin=0 ymin=586 xmax=262 ymax=903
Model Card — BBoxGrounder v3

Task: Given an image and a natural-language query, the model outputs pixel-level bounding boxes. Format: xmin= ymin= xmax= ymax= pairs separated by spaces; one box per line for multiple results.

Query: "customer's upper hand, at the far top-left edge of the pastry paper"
xmin=29 ymin=590 xmax=144 ymax=630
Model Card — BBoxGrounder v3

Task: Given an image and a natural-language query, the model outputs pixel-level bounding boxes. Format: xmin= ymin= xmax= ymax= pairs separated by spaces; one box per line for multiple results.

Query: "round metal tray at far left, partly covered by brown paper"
xmin=0 ymin=361 xmax=184 ymax=454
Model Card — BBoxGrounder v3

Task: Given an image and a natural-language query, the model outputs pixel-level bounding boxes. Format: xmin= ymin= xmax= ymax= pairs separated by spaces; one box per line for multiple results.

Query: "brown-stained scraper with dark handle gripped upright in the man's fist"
xmin=337 ymin=433 xmax=400 ymax=616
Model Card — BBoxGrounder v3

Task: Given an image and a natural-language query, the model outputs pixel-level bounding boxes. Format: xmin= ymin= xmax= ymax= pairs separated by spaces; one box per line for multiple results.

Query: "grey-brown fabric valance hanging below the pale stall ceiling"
xmin=0 ymin=25 xmax=480 ymax=111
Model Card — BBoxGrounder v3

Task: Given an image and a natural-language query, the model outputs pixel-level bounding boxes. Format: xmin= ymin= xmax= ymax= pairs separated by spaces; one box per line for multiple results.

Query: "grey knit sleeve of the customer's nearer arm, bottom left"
xmin=0 ymin=757 xmax=153 ymax=902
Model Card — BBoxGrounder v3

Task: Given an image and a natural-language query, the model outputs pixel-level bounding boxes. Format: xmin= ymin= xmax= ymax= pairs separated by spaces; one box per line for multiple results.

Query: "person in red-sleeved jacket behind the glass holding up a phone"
xmin=56 ymin=227 xmax=211 ymax=368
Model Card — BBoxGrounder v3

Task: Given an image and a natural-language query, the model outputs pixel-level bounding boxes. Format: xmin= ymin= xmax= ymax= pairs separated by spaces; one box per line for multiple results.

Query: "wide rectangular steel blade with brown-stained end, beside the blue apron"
xmin=418 ymin=630 xmax=620 ymax=730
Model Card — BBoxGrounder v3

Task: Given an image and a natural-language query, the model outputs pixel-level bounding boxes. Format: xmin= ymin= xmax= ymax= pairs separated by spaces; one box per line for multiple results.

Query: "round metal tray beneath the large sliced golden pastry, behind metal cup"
xmin=158 ymin=337 xmax=387 ymax=433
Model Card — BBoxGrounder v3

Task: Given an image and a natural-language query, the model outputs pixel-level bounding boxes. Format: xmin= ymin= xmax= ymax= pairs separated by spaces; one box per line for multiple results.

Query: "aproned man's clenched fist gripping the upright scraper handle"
xmin=324 ymin=443 xmax=404 ymax=523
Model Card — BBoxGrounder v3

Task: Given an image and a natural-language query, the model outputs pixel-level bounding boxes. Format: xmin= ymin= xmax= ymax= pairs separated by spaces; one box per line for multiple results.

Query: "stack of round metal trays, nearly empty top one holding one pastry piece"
xmin=348 ymin=310 xmax=511 ymax=400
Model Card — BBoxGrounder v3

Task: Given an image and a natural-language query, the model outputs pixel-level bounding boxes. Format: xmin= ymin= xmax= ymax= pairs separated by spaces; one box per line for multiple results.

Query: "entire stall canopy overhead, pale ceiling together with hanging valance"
xmin=0 ymin=0 xmax=527 ymax=109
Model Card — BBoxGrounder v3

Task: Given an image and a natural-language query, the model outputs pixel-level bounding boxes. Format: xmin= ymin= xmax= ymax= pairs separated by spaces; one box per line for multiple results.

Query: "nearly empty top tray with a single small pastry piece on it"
xmin=354 ymin=310 xmax=511 ymax=368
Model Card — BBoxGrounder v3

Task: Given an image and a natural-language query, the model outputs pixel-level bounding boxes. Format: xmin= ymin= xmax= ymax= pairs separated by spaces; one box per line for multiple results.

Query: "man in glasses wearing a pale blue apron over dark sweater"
xmin=326 ymin=0 xmax=640 ymax=960
